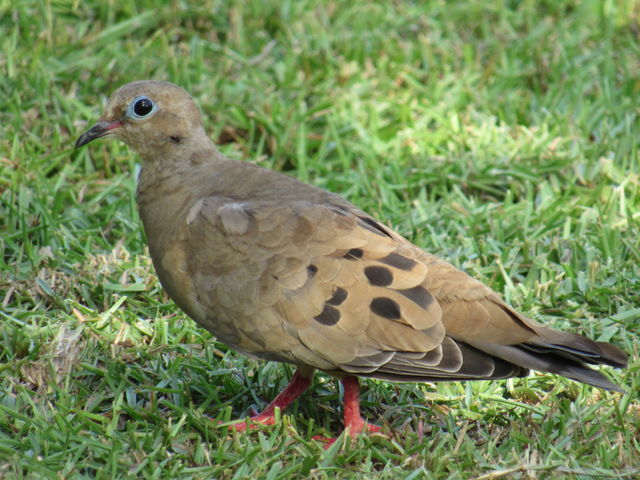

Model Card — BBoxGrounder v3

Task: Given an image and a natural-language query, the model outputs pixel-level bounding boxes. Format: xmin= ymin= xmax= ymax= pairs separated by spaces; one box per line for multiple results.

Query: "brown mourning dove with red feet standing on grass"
xmin=76 ymin=81 xmax=627 ymax=435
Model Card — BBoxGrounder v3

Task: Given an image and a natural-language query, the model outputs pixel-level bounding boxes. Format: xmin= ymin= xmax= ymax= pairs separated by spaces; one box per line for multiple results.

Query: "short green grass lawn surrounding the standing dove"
xmin=0 ymin=0 xmax=640 ymax=480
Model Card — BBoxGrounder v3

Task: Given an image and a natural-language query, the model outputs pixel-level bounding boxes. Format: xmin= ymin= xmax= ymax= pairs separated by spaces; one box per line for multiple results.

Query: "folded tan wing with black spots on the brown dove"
xmin=178 ymin=193 xmax=533 ymax=380
